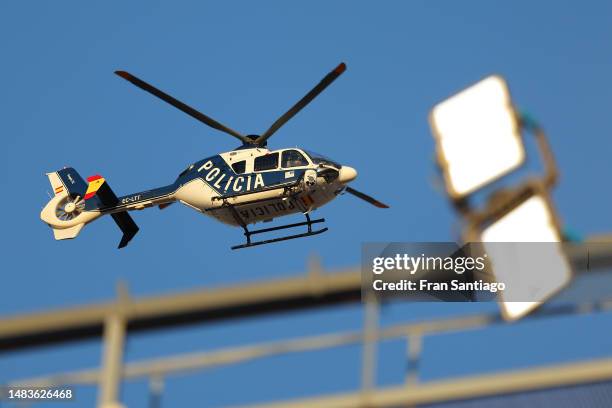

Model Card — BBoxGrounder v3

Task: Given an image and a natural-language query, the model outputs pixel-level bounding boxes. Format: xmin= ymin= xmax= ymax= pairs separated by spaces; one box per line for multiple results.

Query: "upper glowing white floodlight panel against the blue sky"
xmin=429 ymin=75 xmax=525 ymax=199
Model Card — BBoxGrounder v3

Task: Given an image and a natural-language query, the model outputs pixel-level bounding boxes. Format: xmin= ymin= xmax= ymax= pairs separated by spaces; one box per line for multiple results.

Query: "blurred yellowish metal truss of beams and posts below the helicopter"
xmin=0 ymin=244 xmax=612 ymax=408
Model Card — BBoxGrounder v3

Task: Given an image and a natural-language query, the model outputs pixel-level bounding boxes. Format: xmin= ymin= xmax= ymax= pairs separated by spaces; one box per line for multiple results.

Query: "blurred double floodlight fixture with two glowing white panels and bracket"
xmin=429 ymin=75 xmax=572 ymax=320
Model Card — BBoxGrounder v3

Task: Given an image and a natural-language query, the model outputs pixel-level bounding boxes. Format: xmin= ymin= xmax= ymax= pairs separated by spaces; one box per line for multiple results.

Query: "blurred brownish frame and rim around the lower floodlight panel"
xmin=462 ymin=178 xmax=574 ymax=321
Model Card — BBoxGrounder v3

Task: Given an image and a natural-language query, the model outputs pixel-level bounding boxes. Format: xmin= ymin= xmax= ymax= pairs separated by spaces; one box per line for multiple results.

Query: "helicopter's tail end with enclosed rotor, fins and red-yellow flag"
xmin=40 ymin=167 xmax=138 ymax=248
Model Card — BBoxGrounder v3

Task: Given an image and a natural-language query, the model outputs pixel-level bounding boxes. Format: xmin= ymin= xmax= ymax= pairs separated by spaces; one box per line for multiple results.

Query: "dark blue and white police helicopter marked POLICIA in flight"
xmin=40 ymin=63 xmax=388 ymax=249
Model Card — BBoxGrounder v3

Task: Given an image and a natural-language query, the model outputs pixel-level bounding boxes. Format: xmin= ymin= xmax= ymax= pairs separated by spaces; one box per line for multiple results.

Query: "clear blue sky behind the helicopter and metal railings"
xmin=0 ymin=1 xmax=612 ymax=406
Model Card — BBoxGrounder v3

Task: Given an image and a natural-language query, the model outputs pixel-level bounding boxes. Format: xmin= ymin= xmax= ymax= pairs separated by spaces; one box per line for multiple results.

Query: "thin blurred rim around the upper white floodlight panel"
xmin=429 ymin=74 xmax=527 ymax=202
